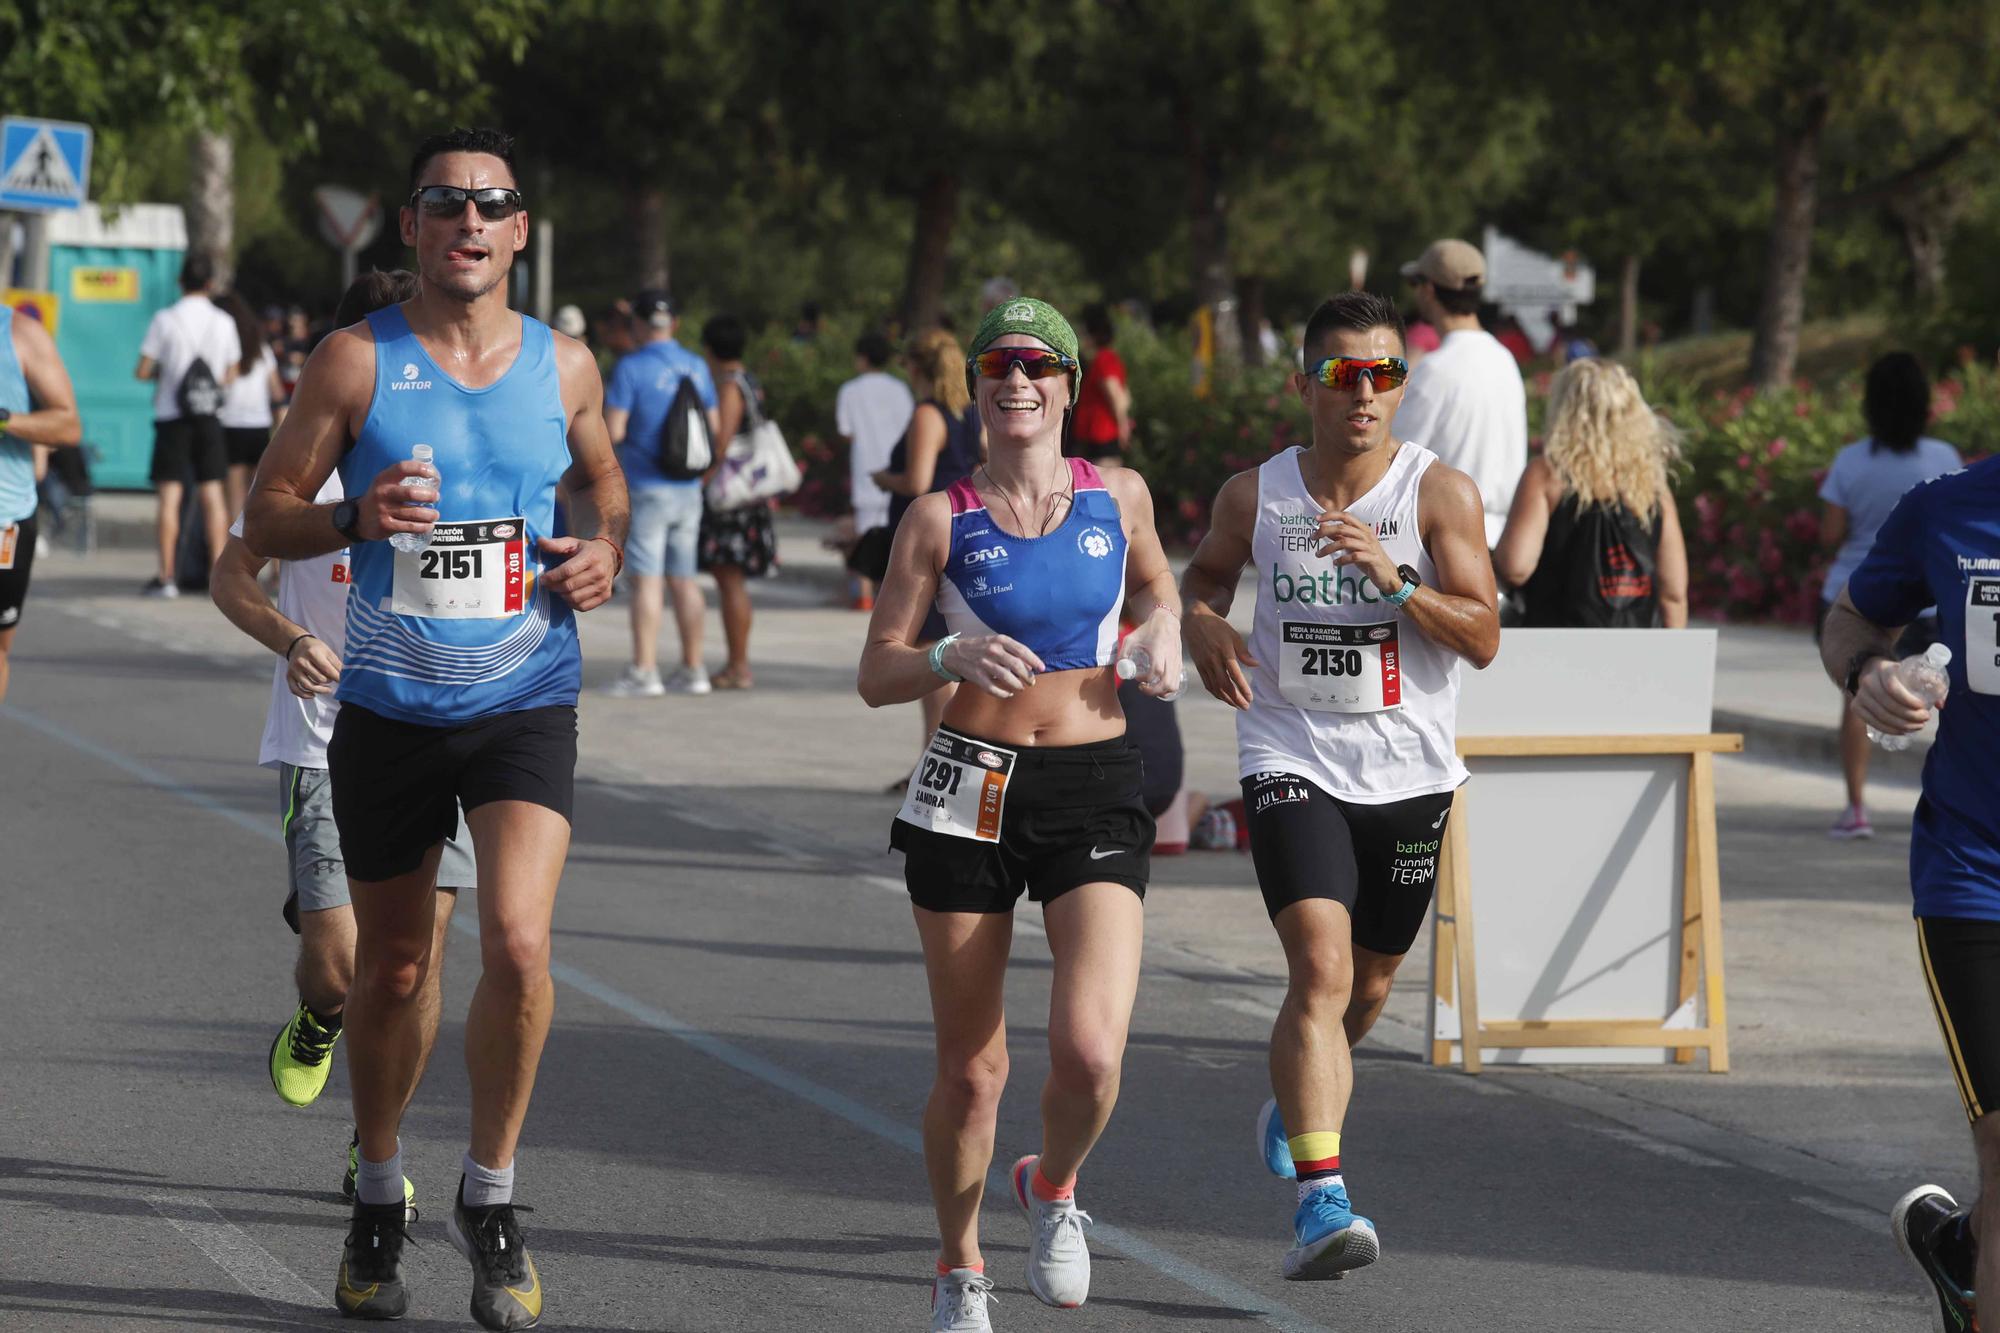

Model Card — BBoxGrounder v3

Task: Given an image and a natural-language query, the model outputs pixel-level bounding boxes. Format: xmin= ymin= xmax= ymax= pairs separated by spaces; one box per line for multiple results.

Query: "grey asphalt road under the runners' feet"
xmin=0 ymin=544 xmax=1964 ymax=1333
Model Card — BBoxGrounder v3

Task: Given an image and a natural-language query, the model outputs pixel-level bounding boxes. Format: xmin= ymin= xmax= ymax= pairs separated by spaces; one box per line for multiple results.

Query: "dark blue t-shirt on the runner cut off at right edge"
xmin=1848 ymin=458 xmax=2000 ymax=921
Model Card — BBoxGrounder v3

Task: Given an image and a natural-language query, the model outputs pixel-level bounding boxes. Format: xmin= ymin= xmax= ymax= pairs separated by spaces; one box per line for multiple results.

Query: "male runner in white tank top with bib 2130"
xmin=1182 ymin=292 xmax=1500 ymax=1279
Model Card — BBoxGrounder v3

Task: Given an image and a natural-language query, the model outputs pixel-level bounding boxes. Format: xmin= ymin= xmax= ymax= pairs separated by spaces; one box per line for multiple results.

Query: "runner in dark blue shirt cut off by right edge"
xmin=1820 ymin=460 xmax=2000 ymax=1333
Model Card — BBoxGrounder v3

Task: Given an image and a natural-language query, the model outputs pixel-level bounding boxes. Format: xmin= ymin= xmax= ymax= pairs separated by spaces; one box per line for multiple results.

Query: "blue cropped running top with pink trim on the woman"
xmin=938 ymin=458 xmax=1126 ymax=671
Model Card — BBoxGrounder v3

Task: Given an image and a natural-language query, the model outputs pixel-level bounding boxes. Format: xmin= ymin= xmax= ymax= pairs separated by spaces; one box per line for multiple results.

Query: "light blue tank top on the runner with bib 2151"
xmin=340 ymin=306 xmax=582 ymax=727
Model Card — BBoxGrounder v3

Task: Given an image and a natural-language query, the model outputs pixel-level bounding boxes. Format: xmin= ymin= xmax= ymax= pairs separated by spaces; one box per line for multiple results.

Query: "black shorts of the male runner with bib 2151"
xmin=326 ymin=705 xmax=576 ymax=883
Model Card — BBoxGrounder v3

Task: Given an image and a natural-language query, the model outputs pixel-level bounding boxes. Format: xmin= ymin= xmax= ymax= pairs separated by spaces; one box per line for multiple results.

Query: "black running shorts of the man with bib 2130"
xmin=1244 ymin=773 xmax=1452 ymax=957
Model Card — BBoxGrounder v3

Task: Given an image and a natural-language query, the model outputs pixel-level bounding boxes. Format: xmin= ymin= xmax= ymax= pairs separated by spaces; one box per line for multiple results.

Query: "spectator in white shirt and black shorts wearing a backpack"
xmin=134 ymin=252 xmax=242 ymax=596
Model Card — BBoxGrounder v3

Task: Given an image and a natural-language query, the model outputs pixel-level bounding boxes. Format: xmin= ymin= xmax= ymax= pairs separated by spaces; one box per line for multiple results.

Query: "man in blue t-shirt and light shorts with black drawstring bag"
xmin=604 ymin=288 xmax=720 ymax=699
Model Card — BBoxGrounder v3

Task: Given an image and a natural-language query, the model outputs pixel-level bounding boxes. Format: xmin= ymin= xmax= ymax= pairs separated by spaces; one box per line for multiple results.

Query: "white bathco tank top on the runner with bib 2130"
xmin=1236 ymin=444 xmax=1466 ymax=805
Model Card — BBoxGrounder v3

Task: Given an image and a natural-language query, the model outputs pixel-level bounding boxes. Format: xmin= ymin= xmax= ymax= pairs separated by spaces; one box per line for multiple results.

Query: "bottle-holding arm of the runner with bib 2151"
xmin=244 ymin=326 xmax=438 ymax=560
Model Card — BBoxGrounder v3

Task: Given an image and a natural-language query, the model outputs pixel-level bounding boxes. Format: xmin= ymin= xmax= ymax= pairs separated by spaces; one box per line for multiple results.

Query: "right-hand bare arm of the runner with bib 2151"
xmin=542 ymin=334 xmax=632 ymax=610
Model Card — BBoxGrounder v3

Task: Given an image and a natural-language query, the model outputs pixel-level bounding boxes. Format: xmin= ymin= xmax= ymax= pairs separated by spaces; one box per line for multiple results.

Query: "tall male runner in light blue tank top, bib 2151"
xmin=244 ymin=130 xmax=630 ymax=1329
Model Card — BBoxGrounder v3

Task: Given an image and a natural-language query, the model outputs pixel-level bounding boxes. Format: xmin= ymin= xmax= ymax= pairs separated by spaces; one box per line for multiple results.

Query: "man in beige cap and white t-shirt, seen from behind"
xmin=1396 ymin=240 xmax=1528 ymax=548
